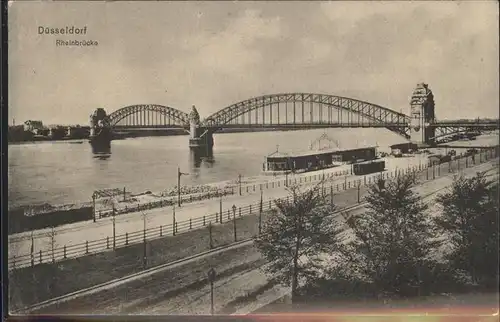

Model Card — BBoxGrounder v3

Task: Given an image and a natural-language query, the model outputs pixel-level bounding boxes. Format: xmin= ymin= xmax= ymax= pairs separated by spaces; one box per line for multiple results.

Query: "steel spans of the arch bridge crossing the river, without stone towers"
xmin=95 ymin=93 xmax=500 ymax=141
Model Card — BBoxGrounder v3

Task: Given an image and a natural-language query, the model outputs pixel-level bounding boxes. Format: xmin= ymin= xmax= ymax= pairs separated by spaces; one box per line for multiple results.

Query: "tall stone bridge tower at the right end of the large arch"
xmin=410 ymin=83 xmax=435 ymax=146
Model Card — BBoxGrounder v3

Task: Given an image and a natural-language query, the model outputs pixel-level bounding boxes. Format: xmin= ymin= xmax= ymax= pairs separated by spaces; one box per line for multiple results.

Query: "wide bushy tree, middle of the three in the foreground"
xmin=334 ymin=174 xmax=437 ymax=295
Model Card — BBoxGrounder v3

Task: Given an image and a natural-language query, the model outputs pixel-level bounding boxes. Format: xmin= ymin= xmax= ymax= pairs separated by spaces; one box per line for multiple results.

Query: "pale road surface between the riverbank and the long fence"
xmin=9 ymin=155 xmax=434 ymax=257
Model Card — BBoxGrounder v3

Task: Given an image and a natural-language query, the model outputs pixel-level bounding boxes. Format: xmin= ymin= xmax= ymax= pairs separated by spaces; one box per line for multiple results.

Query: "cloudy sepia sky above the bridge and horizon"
xmin=8 ymin=1 xmax=499 ymax=125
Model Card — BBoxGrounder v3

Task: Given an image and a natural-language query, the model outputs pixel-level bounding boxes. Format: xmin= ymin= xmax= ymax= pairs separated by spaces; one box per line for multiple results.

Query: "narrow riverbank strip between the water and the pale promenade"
xmin=9 ymin=135 xmax=498 ymax=231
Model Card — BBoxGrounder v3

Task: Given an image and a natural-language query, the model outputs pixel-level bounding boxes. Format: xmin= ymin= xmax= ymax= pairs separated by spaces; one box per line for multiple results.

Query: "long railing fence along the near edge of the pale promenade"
xmin=9 ymin=148 xmax=499 ymax=269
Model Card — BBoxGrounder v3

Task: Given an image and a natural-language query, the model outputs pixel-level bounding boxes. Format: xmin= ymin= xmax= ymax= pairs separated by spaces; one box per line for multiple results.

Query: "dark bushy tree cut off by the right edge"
xmin=435 ymin=173 xmax=499 ymax=284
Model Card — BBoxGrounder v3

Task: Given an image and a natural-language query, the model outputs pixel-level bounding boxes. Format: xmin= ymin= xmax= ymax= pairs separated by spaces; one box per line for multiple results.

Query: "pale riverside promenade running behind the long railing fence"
xmin=9 ymin=155 xmax=427 ymax=258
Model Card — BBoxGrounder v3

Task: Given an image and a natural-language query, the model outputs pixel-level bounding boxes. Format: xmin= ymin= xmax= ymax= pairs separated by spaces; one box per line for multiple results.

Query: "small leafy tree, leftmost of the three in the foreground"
xmin=255 ymin=185 xmax=342 ymax=301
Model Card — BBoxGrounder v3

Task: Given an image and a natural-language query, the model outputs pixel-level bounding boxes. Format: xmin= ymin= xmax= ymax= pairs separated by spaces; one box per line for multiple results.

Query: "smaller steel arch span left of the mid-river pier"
xmin=108 ymin=104 xmax=189 ymax=127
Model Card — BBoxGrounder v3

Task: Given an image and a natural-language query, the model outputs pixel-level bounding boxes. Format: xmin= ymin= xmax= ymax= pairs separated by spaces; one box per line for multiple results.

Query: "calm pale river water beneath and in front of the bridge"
xmin=8 ymin=129 xmax=412 ymax=208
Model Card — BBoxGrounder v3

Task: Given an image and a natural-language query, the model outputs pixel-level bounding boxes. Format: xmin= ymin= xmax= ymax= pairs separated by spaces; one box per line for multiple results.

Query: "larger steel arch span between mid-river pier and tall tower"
xmin=203 ymin=93 xmax=410 ymax=138
